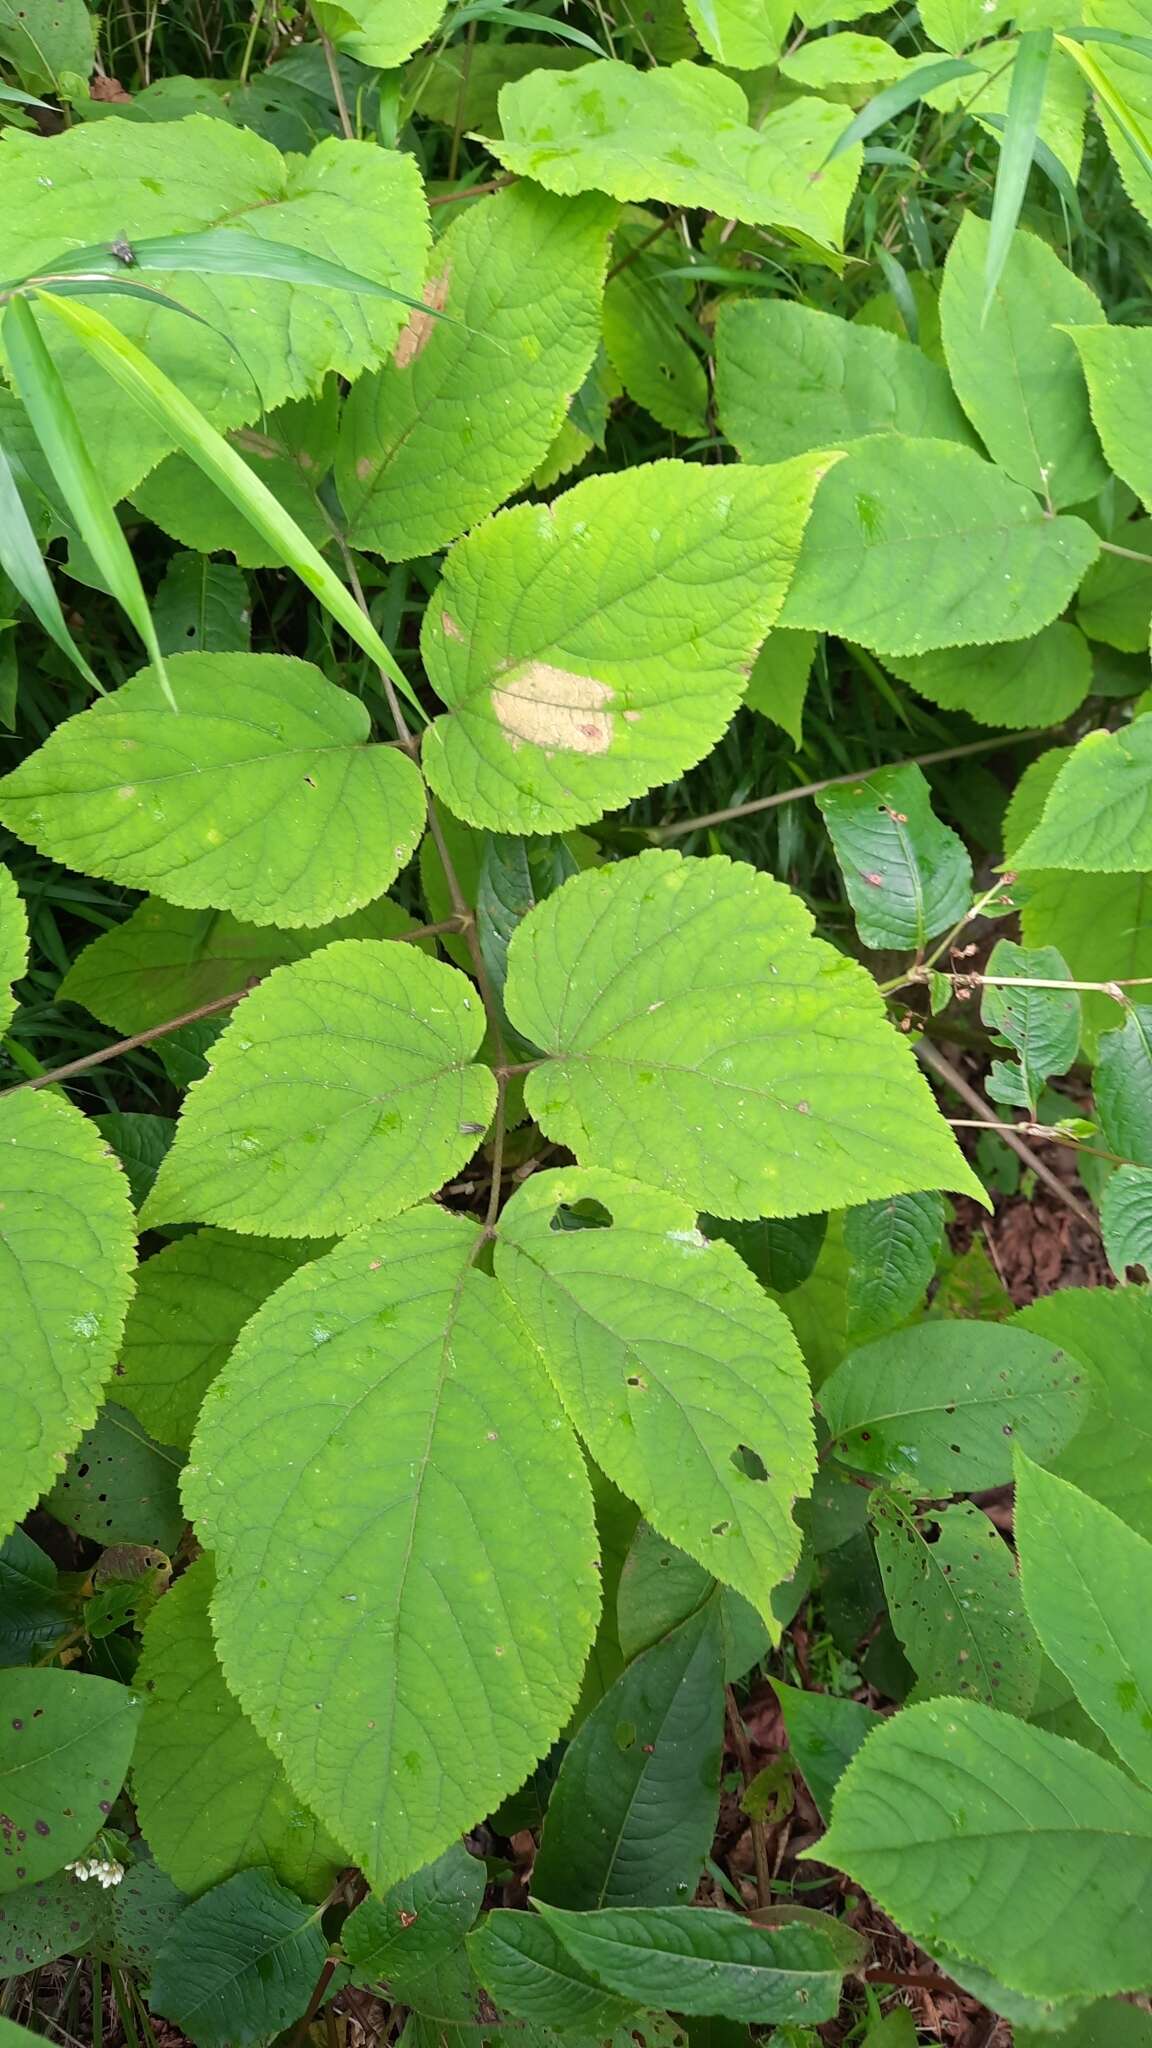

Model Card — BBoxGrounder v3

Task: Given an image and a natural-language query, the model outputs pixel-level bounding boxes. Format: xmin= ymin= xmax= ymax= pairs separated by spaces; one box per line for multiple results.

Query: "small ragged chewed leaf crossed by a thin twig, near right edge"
xmin=980 ymin=938 xmax=1080 ymax=1116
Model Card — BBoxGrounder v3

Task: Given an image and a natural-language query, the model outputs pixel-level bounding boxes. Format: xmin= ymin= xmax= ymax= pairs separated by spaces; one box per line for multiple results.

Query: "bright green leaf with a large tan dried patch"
xmin=420 ymin=460 xmax=832 ymax=831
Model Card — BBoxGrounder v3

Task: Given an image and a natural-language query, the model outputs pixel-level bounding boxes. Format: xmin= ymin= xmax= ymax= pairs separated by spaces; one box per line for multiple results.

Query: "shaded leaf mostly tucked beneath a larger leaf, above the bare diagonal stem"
xmin=888 ymin=618 xmax=1093 ymax=731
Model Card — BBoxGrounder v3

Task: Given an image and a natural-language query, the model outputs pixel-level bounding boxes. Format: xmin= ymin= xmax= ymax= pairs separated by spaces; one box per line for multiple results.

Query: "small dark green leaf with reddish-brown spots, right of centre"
xmin=816 ymin=765 xmax=972 ymax=950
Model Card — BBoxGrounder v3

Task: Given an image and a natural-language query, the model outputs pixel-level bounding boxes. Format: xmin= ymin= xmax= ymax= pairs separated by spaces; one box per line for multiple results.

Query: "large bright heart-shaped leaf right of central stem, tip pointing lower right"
xmin=506 ymin=852 xmax=982 ymax=1217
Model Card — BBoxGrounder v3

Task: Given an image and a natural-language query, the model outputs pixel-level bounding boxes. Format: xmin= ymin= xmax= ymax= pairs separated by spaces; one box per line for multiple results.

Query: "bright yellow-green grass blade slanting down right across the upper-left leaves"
xmin=38 ymin=293 xmax=424 ymax=719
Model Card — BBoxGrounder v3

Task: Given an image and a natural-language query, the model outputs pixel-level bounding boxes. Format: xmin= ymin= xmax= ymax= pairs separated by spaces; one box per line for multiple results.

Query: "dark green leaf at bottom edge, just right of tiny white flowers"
xmin=148 ymin=1870 xmax=328 ymax=2048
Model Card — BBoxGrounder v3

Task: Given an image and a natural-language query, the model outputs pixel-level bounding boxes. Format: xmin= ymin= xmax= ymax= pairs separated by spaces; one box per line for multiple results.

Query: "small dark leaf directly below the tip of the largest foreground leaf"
xmin=340 ymin=1841 xmax=486 ymax=1999
